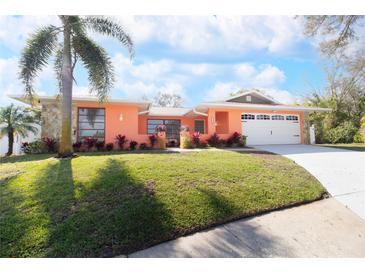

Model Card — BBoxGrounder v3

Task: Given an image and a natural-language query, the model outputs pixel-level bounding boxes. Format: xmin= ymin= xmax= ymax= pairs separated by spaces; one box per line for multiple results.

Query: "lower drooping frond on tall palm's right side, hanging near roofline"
xmin=72 ymin=35 xmax=114 ymax=101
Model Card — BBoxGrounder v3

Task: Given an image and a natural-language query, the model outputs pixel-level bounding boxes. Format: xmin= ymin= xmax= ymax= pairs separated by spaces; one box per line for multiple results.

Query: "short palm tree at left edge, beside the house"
xmin=0 ymin=104 xmax=40 ymax=156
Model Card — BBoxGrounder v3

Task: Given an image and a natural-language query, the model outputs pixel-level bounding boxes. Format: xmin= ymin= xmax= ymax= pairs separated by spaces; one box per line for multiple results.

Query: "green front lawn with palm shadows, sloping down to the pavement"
xmin=0 ymin=150 xmax=325 ymax=257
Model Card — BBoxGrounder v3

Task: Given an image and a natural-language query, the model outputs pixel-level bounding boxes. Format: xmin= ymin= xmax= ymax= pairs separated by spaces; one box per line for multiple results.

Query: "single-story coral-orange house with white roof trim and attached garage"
xmin=12 ymin=91 xmax=329 ymax=145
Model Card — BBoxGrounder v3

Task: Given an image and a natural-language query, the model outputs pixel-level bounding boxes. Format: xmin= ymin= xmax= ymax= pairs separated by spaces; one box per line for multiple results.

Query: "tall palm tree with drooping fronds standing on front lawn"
xmin=20 ymin=15 xmax=134 ymax=157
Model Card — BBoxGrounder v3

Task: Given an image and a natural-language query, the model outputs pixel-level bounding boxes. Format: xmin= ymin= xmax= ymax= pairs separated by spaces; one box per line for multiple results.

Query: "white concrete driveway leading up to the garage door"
xmin=255 ymin=145 xmax=365 ymax=220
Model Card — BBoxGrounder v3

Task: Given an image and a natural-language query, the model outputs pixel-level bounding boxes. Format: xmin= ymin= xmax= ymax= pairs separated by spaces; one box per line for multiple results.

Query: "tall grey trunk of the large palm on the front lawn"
xmin=58 ymin=16 xmax=73 ymax=157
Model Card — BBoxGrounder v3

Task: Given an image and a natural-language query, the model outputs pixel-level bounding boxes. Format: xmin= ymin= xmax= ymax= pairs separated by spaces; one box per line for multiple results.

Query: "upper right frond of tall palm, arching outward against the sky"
xmin=83 ymin=16 xmax=134 ymax=58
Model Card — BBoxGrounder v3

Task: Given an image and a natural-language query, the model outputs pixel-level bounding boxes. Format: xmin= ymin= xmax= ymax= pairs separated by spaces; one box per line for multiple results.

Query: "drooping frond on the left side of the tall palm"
xmin=19 ymin=25 xmax=57 ymax=99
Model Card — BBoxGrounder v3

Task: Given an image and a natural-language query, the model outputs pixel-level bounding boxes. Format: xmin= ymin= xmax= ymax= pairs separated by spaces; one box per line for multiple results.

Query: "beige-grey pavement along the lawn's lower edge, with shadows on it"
xmin=128 ymin=198 xmax=365 ymax=258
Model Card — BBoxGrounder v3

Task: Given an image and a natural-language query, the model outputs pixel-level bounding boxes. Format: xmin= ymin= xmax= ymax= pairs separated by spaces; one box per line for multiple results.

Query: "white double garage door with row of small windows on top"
xmin=242 ymin=113 xmax=300 ymax=145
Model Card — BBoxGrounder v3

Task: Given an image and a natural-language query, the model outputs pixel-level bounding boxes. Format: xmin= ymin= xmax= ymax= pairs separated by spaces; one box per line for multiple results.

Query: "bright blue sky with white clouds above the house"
xmin=0 ymin=16 xmax=325 ymax=106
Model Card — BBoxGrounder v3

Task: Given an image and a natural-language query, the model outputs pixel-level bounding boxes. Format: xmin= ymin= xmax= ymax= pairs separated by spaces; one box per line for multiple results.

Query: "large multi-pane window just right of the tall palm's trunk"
xmin=78 ymin=108 xmax=105 ymax=141
